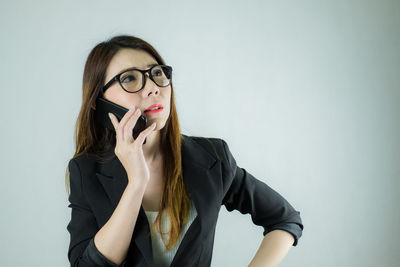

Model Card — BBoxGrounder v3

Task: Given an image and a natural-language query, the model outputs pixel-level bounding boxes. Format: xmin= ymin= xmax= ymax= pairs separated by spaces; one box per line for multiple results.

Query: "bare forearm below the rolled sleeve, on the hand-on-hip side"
xmin=248 ymin=229 xmax=295 ymax=267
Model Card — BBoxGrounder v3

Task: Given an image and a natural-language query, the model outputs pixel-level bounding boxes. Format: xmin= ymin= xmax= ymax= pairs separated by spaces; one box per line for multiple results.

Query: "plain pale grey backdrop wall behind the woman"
xmin=0 ymin=0 xmax=400 ymax=267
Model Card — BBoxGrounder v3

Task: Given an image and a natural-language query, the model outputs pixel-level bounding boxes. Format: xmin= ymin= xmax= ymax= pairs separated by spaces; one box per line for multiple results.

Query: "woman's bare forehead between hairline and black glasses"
xmin=106 ymin=48 xmax=157 ymax=79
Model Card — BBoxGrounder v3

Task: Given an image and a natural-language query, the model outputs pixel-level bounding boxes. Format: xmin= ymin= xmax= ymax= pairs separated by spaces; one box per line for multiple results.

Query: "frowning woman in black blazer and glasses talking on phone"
xmin=66 ymin=35 xmax=303 ymax=266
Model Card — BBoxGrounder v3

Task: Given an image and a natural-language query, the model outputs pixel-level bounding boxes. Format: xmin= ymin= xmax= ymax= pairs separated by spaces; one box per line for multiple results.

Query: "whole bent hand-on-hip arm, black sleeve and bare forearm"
xmin=221 ymin=139 xmax=304 ymax=267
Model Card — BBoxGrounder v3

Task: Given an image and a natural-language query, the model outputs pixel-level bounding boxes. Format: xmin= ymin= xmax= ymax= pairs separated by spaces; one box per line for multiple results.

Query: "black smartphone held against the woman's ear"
xmin=94 ymin=97 xmax=147 ymax=144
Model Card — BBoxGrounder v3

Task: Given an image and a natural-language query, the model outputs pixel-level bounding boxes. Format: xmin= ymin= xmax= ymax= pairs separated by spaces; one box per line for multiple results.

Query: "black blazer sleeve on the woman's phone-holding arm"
xmin=67 ymin=159 xmax=126 ymax=267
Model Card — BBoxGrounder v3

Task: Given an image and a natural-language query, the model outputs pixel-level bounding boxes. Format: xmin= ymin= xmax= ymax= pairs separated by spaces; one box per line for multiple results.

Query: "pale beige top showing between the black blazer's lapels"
xmin=145 ymin=201 xmax=197 ymax=267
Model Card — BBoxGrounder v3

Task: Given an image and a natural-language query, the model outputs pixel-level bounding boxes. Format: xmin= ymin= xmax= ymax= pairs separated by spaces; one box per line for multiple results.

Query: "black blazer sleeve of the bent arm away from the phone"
xmin=221 ymin=139 xmax=304 ymax=246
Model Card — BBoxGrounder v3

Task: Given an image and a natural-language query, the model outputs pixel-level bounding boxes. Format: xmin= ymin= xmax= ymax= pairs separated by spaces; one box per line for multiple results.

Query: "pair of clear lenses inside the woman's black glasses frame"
xmin=120 ymin=66 xmax=171 ymax=92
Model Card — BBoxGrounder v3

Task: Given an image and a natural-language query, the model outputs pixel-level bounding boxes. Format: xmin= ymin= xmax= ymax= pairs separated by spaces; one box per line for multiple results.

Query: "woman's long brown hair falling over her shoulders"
xmin=65 ymin=35 xmax=190 ymax=249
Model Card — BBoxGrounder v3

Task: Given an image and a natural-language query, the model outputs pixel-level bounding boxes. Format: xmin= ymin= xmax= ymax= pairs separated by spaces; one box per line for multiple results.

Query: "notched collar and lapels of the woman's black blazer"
xmin=96 ymin=134 xmax=217 ymax=266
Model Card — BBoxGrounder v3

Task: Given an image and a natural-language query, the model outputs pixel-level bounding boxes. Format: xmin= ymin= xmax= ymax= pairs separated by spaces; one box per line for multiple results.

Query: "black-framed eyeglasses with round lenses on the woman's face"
xmin=102 ymin=65 xmax=172 ymax=93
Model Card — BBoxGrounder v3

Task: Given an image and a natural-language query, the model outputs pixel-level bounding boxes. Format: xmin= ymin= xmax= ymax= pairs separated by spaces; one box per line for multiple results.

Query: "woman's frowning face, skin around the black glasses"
xmin=103 ymin=48 xmax=171 ymax=131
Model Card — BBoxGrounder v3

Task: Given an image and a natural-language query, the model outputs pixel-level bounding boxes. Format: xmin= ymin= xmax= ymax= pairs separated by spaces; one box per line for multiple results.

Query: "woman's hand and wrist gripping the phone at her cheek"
xmin=109 ymin=107 xmax=156 ymax=188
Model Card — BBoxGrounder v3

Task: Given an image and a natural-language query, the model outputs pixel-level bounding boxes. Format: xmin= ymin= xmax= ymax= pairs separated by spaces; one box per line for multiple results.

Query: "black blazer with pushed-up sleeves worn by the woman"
xmin=67 ymin=134 xmax=303 ymax=267
